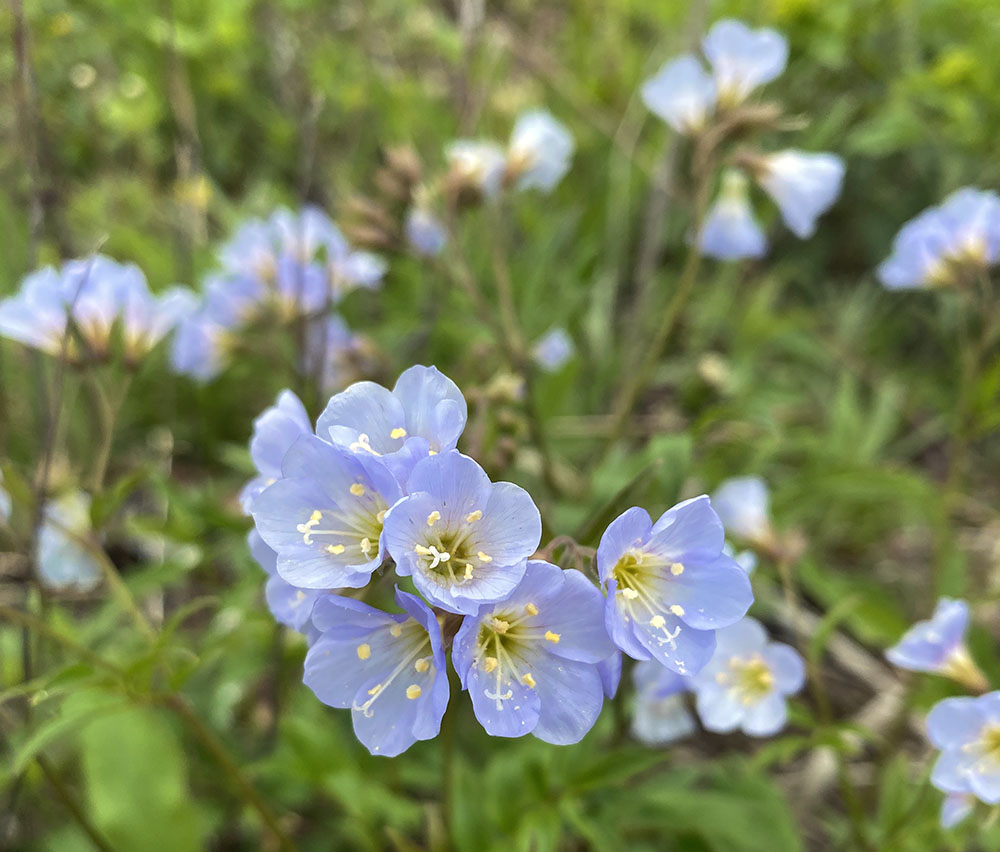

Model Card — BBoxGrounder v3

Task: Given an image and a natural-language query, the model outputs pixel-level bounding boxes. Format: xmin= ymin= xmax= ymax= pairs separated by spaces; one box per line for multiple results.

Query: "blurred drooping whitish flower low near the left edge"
xmin=38 ymin=491 xmax=102 ymax=592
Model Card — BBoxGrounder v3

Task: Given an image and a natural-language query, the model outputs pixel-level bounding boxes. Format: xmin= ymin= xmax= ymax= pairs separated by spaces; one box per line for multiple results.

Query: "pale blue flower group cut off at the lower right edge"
xmin=886 ymin=598 xmax=1000 ymax=828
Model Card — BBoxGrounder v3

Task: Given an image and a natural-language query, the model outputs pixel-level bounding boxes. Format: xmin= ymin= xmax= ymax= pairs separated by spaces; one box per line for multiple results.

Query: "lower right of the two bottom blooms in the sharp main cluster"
xmin=452 ymin=561 xmax=613 ymax=745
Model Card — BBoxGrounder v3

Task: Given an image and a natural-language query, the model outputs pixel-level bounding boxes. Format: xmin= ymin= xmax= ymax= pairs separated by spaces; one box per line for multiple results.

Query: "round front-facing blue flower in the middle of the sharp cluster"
xmin=384 ymin=450 xmax=540 ymax=612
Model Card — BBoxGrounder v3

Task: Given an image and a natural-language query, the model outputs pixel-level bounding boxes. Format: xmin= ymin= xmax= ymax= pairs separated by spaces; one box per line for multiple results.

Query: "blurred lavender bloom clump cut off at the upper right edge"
xmin=878 ymin=187 xmax=1000 ymax=290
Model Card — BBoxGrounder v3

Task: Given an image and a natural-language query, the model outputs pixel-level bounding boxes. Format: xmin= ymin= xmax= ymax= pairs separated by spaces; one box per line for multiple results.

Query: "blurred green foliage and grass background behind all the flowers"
xmin=0 ymin=0 xmax=1000 ymax=852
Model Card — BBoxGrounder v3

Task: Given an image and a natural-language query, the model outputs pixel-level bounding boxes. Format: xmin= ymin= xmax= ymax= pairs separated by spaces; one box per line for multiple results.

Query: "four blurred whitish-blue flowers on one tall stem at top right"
xmin=642 ymin=19 xmax=844 ymax=260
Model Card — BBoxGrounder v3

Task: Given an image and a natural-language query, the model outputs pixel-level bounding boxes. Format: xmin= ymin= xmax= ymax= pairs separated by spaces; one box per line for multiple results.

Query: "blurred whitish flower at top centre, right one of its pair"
xmin=507 ymin=110 xmax=574 ymax=192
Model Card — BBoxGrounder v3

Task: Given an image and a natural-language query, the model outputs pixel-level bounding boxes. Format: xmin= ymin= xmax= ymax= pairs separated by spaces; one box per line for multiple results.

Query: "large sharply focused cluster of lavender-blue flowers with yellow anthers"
xmin=242 ymin=366 xmax=752 ymax=755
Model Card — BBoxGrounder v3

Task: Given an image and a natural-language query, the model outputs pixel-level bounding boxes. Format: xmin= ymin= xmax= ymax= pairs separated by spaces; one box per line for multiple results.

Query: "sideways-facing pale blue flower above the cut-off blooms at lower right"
xmin=886 ymin=598 xmax=986 ymax=690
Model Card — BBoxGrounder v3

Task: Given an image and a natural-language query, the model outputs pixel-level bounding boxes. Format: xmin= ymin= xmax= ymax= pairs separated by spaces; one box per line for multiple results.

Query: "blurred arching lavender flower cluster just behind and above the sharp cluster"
xmin=172 ymin=207 xmax=386 ymax=387
